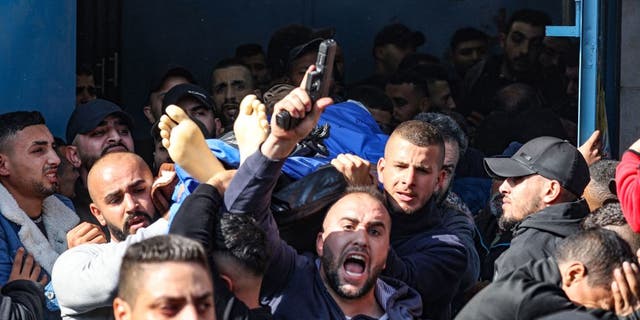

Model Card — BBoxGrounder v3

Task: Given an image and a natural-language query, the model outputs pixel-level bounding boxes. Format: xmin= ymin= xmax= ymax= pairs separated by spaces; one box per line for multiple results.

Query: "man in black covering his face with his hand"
xmin=456 ymin=228 xmax=640 ymax=320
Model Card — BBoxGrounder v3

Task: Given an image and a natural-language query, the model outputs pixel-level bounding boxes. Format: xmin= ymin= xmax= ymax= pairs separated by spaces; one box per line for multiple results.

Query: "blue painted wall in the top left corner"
xmin=0 ymin=0 xmax=76 ymax=137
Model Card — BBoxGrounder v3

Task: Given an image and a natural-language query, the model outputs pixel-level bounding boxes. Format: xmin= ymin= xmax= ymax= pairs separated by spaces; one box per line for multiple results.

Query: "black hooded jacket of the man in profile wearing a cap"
xmin=493 ymin=200 xmax=589 ymax=279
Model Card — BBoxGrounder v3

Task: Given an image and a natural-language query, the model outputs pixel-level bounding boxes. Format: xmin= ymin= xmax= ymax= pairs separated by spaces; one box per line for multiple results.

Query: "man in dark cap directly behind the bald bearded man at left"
xmin=66 ymin=99 xmax=134 ymax=224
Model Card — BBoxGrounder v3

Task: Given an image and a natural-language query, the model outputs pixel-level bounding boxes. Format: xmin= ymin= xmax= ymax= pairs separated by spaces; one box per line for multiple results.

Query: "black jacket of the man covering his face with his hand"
xmin=456 ymin=258 xmax=639 ymax=320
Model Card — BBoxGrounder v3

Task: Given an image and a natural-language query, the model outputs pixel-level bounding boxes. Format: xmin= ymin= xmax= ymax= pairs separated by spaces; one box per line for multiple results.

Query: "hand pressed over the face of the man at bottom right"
xmin=611 ymin=262 xmax=640 ymax=317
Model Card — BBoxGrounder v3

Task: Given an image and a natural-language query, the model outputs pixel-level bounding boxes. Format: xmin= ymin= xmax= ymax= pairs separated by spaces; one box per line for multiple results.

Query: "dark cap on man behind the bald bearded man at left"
xmin=66 ymin=99 xmax=133 ymax=143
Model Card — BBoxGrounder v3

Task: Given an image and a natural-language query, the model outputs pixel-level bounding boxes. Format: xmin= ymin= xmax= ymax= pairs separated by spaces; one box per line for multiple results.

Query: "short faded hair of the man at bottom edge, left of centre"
xmin=118 ymin=235 xmax=209 ymax=306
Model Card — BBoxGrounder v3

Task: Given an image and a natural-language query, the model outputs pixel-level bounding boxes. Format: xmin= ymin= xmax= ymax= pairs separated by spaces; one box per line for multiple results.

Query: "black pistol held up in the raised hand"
xmin=276 ymin=39 xmax=337 ymax=130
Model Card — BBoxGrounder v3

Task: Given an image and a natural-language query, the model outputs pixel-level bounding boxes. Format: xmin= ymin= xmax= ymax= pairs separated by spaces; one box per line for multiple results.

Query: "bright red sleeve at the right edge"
xmin=616 ymin=150 xmax=640 ymax=232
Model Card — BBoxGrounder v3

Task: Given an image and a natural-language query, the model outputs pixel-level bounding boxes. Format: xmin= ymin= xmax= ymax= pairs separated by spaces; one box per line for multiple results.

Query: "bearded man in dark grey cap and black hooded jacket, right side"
xmin=484 ymin=137 xmax=590 ymax=279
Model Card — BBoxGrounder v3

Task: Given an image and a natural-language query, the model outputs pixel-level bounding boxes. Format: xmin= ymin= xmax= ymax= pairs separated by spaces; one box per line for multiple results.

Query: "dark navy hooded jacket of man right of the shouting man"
xmin=383 ymin=197 xmax=467 ymax=319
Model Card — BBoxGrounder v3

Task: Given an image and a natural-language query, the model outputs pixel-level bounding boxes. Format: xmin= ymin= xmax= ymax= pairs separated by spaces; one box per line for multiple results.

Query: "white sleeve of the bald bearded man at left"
xmin=51 ymin=219 xmax=168 ymax=315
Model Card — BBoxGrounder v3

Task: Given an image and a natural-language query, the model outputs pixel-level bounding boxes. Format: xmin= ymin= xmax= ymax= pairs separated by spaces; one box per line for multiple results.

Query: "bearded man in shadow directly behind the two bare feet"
xmin=211 ymin=59 xmax=259 ymax=132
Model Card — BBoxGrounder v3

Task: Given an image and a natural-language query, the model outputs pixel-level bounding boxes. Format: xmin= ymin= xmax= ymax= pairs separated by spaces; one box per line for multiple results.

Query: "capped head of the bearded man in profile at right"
xmin=484 ymin=137 xmax=590 ymax=230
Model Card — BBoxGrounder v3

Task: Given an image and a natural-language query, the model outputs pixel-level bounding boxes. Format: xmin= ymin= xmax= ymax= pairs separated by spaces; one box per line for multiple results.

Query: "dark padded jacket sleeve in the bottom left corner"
xmin=0 ymin=280 xmax=45 ymax=320
